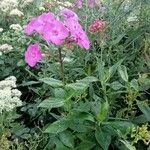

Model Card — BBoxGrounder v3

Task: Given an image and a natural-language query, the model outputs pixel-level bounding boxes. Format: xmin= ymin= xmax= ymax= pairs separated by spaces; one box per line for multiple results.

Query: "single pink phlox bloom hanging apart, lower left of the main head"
xmin=25 ymin=44 xmax=42 ymax=67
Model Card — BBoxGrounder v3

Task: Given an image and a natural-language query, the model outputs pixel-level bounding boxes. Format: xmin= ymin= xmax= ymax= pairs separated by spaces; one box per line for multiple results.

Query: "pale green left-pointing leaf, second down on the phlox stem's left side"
xmin=38 ymin=97 xmax=65 ymax=109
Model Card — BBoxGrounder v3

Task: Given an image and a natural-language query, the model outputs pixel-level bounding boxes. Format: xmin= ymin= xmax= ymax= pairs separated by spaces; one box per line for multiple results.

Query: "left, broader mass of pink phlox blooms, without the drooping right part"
xmin=24 ymin=12 xmax=69 ymax=45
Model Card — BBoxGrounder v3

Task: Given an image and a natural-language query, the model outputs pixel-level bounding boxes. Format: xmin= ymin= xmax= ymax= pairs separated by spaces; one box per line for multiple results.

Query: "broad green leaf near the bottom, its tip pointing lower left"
xmin=44 ymin=119 xmax=69 ymax=134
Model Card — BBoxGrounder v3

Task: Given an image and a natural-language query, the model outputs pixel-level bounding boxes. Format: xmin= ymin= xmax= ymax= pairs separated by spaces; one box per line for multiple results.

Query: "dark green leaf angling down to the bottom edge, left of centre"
xmin=59 ymin=131 xmax=74 ymax=148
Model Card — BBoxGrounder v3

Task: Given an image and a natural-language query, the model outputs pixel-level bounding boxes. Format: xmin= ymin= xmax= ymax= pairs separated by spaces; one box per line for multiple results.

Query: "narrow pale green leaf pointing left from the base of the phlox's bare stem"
xmin=39 ymin=78 xmax=63 ymax=87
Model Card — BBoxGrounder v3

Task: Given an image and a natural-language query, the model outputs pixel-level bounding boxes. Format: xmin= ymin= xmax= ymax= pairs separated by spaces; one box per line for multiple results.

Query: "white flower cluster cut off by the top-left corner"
xmin=0 ymin=0 xmax=18 ymax=12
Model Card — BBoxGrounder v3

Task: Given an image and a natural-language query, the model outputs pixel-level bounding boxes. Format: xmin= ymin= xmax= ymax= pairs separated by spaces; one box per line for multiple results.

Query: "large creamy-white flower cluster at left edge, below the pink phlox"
xmin=0 ymin=76 xmax=22 ymax=113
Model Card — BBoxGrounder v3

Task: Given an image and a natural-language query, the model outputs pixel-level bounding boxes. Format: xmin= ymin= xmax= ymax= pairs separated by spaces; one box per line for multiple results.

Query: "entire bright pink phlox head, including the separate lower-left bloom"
xmin=24 ymin=8 xmax=90 ymax=67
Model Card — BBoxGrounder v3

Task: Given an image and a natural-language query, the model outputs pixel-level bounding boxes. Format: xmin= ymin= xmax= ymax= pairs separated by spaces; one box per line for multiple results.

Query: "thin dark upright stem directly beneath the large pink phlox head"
xmin=58 ymin=47 xmax=65 ymax=84
